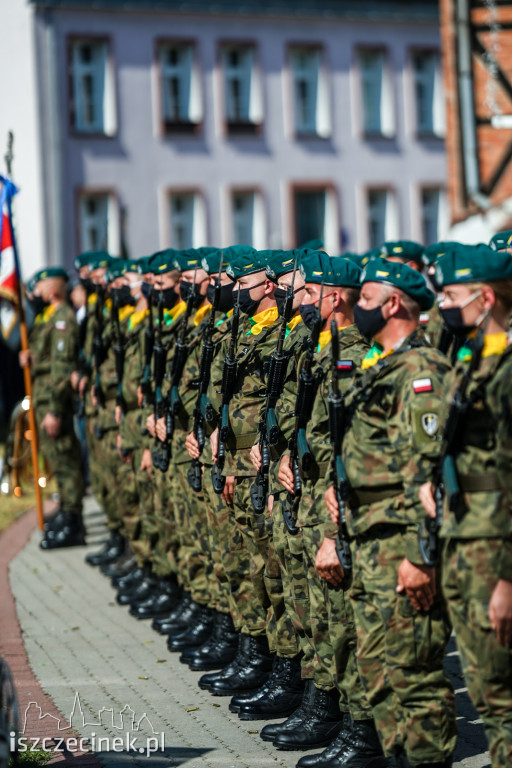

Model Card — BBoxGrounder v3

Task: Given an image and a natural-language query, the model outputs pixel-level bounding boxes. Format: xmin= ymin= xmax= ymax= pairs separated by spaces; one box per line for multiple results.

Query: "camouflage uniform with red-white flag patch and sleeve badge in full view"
xmin=343 ymin=330 xmax=456 ymax=765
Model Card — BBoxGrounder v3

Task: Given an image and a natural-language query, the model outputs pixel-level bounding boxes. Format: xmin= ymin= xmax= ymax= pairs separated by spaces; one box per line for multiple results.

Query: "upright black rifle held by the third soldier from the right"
xmin=283 ymin=283 xmax=324 ymax=536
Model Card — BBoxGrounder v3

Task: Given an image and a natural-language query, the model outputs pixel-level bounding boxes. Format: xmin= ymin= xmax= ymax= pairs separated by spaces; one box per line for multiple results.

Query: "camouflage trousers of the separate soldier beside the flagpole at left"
xmin=35 ymin=404 xmax=85 ymax=515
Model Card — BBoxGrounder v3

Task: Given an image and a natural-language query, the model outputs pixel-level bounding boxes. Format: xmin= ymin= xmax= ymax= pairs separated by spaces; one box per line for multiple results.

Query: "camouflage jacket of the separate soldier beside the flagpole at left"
xmin=29 ymin=303 xmax=78 ymax=416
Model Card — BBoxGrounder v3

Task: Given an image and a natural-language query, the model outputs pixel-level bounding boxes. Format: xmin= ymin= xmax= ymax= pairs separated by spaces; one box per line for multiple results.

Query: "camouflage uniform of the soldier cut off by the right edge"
xmin=441 ymin=344 xmax=512 ymax=768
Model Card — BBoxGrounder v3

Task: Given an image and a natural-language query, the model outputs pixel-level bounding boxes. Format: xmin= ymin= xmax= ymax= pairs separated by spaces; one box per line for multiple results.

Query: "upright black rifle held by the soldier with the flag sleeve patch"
xmin=327 ymin=320 xmax=352 ymax=575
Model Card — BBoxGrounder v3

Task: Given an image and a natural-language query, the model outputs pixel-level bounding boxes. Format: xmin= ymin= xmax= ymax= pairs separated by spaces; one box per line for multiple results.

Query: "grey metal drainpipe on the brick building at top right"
xmin=456 ymin=0 xmax=491 ymax=210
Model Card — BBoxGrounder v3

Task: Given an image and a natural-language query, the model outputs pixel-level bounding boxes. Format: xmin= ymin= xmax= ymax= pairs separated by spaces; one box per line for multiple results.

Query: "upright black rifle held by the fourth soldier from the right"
xmin=251 ymin=259 xmax=297 ymax=514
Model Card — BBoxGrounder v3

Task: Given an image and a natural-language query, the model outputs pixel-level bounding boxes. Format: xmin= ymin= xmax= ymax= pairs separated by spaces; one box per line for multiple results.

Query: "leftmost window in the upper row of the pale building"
xmin=71 ymin=40 xmax=116 ymax=136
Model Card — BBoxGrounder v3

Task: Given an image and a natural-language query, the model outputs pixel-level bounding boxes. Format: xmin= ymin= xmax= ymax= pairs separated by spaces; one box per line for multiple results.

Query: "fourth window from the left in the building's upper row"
xmin=291 ymin=47 xmax=330 ymax=138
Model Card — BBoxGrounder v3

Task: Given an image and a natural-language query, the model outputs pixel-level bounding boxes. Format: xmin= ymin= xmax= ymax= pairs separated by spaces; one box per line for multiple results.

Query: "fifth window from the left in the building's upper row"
xmin=359 ymin=48 xmax=395 ymax=138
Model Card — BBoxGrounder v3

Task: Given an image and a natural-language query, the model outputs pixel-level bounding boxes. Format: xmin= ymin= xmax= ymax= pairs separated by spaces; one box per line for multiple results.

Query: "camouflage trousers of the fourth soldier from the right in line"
xmin=272 ymin=493 xmax=315 ymax=679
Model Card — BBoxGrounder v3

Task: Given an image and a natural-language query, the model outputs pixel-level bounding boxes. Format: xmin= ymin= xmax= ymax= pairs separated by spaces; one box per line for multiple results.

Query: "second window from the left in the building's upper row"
xmin=159 ymin=43 xmax=202 ymax=132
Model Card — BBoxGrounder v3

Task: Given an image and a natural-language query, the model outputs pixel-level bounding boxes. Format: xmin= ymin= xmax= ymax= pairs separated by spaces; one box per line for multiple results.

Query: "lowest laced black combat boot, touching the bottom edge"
xmin=297 ymin=716 xmax=389 ymax=768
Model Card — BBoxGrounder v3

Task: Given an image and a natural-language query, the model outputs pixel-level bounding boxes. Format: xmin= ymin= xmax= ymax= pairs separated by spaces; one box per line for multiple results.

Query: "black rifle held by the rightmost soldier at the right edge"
xmin=418 ymin=329 xmax=484 ymax=568
